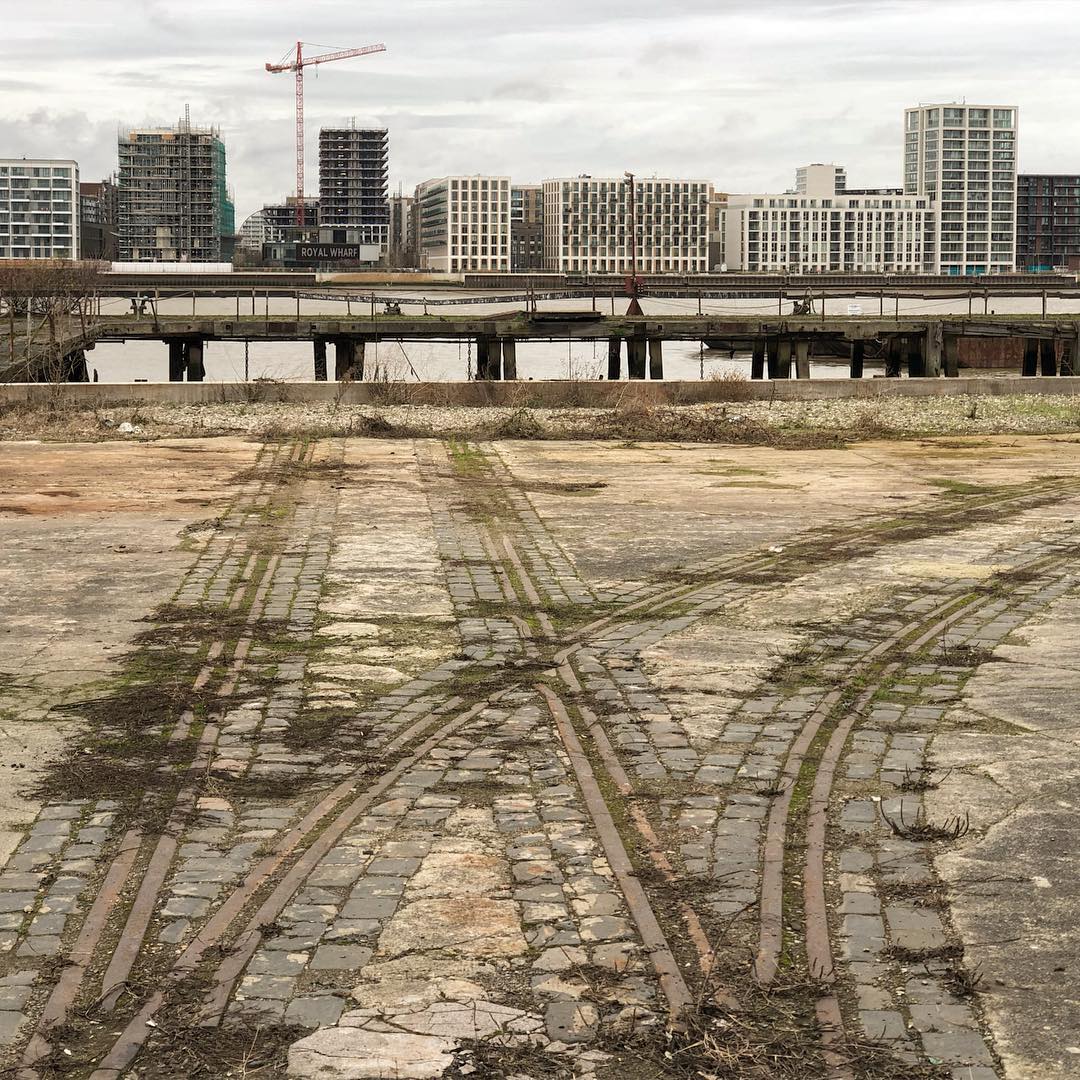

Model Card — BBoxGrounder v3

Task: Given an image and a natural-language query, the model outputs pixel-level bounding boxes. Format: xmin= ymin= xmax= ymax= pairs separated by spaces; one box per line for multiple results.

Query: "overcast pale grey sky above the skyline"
xmin=0 ymin=0 xmax=1080 ymax=226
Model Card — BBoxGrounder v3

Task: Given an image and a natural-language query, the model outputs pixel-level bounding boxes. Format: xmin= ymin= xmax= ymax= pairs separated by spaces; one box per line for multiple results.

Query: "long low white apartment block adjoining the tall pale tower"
xmin=721 ymin=166 xmax=934 ymax=273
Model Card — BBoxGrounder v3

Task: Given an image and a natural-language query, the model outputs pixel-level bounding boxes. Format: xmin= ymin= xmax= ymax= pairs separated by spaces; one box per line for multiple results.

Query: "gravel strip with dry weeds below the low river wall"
xmin=6 ymin=394 xmax=1080 ymax=443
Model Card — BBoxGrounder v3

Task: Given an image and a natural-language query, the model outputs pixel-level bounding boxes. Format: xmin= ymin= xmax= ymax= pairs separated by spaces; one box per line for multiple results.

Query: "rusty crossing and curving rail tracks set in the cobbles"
xmin=2 ymin=434 xmax=1080 ymax=1080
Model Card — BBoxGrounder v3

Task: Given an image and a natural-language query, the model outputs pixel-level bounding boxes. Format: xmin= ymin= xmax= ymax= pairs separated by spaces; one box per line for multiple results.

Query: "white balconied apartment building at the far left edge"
xmin=0 ymin=158 xmax=79 ymax=259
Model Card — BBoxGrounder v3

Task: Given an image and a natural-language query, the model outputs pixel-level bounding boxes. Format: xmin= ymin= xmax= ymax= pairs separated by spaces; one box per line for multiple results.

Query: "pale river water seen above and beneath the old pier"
xmin=86 ymin=288 xmax=1080 ymax=382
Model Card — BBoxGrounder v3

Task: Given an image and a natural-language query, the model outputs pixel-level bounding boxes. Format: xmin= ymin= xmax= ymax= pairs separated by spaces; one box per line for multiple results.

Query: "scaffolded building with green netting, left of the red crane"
xmin=117 ymin=119 xmax=235 ymax=262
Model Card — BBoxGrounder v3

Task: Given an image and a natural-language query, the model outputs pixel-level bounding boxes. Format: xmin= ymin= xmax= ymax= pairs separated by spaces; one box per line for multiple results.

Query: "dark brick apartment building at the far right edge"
xmin=1016 ymin=174 xmax=1080 ymax=272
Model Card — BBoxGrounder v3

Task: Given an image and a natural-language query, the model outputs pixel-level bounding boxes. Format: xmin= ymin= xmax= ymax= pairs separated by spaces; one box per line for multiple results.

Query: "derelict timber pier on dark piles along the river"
xmin=42 ymin=310 xmax=1080 ymax=382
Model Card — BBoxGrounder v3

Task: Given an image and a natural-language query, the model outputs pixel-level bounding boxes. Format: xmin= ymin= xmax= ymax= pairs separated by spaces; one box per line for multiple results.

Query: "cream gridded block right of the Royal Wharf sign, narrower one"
xmin=414 ymin=176 xmax=510 ymax=273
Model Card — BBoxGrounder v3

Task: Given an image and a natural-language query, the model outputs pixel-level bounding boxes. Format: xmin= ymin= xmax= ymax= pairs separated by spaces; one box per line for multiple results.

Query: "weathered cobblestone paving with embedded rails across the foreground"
xmin=0 ymin=441 xmax=1080 ymax=1080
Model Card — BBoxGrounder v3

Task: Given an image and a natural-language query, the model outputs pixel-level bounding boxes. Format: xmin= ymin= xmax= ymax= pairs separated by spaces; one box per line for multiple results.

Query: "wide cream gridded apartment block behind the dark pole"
xmin=543 ymin=176 xmax=711 ymax=273
